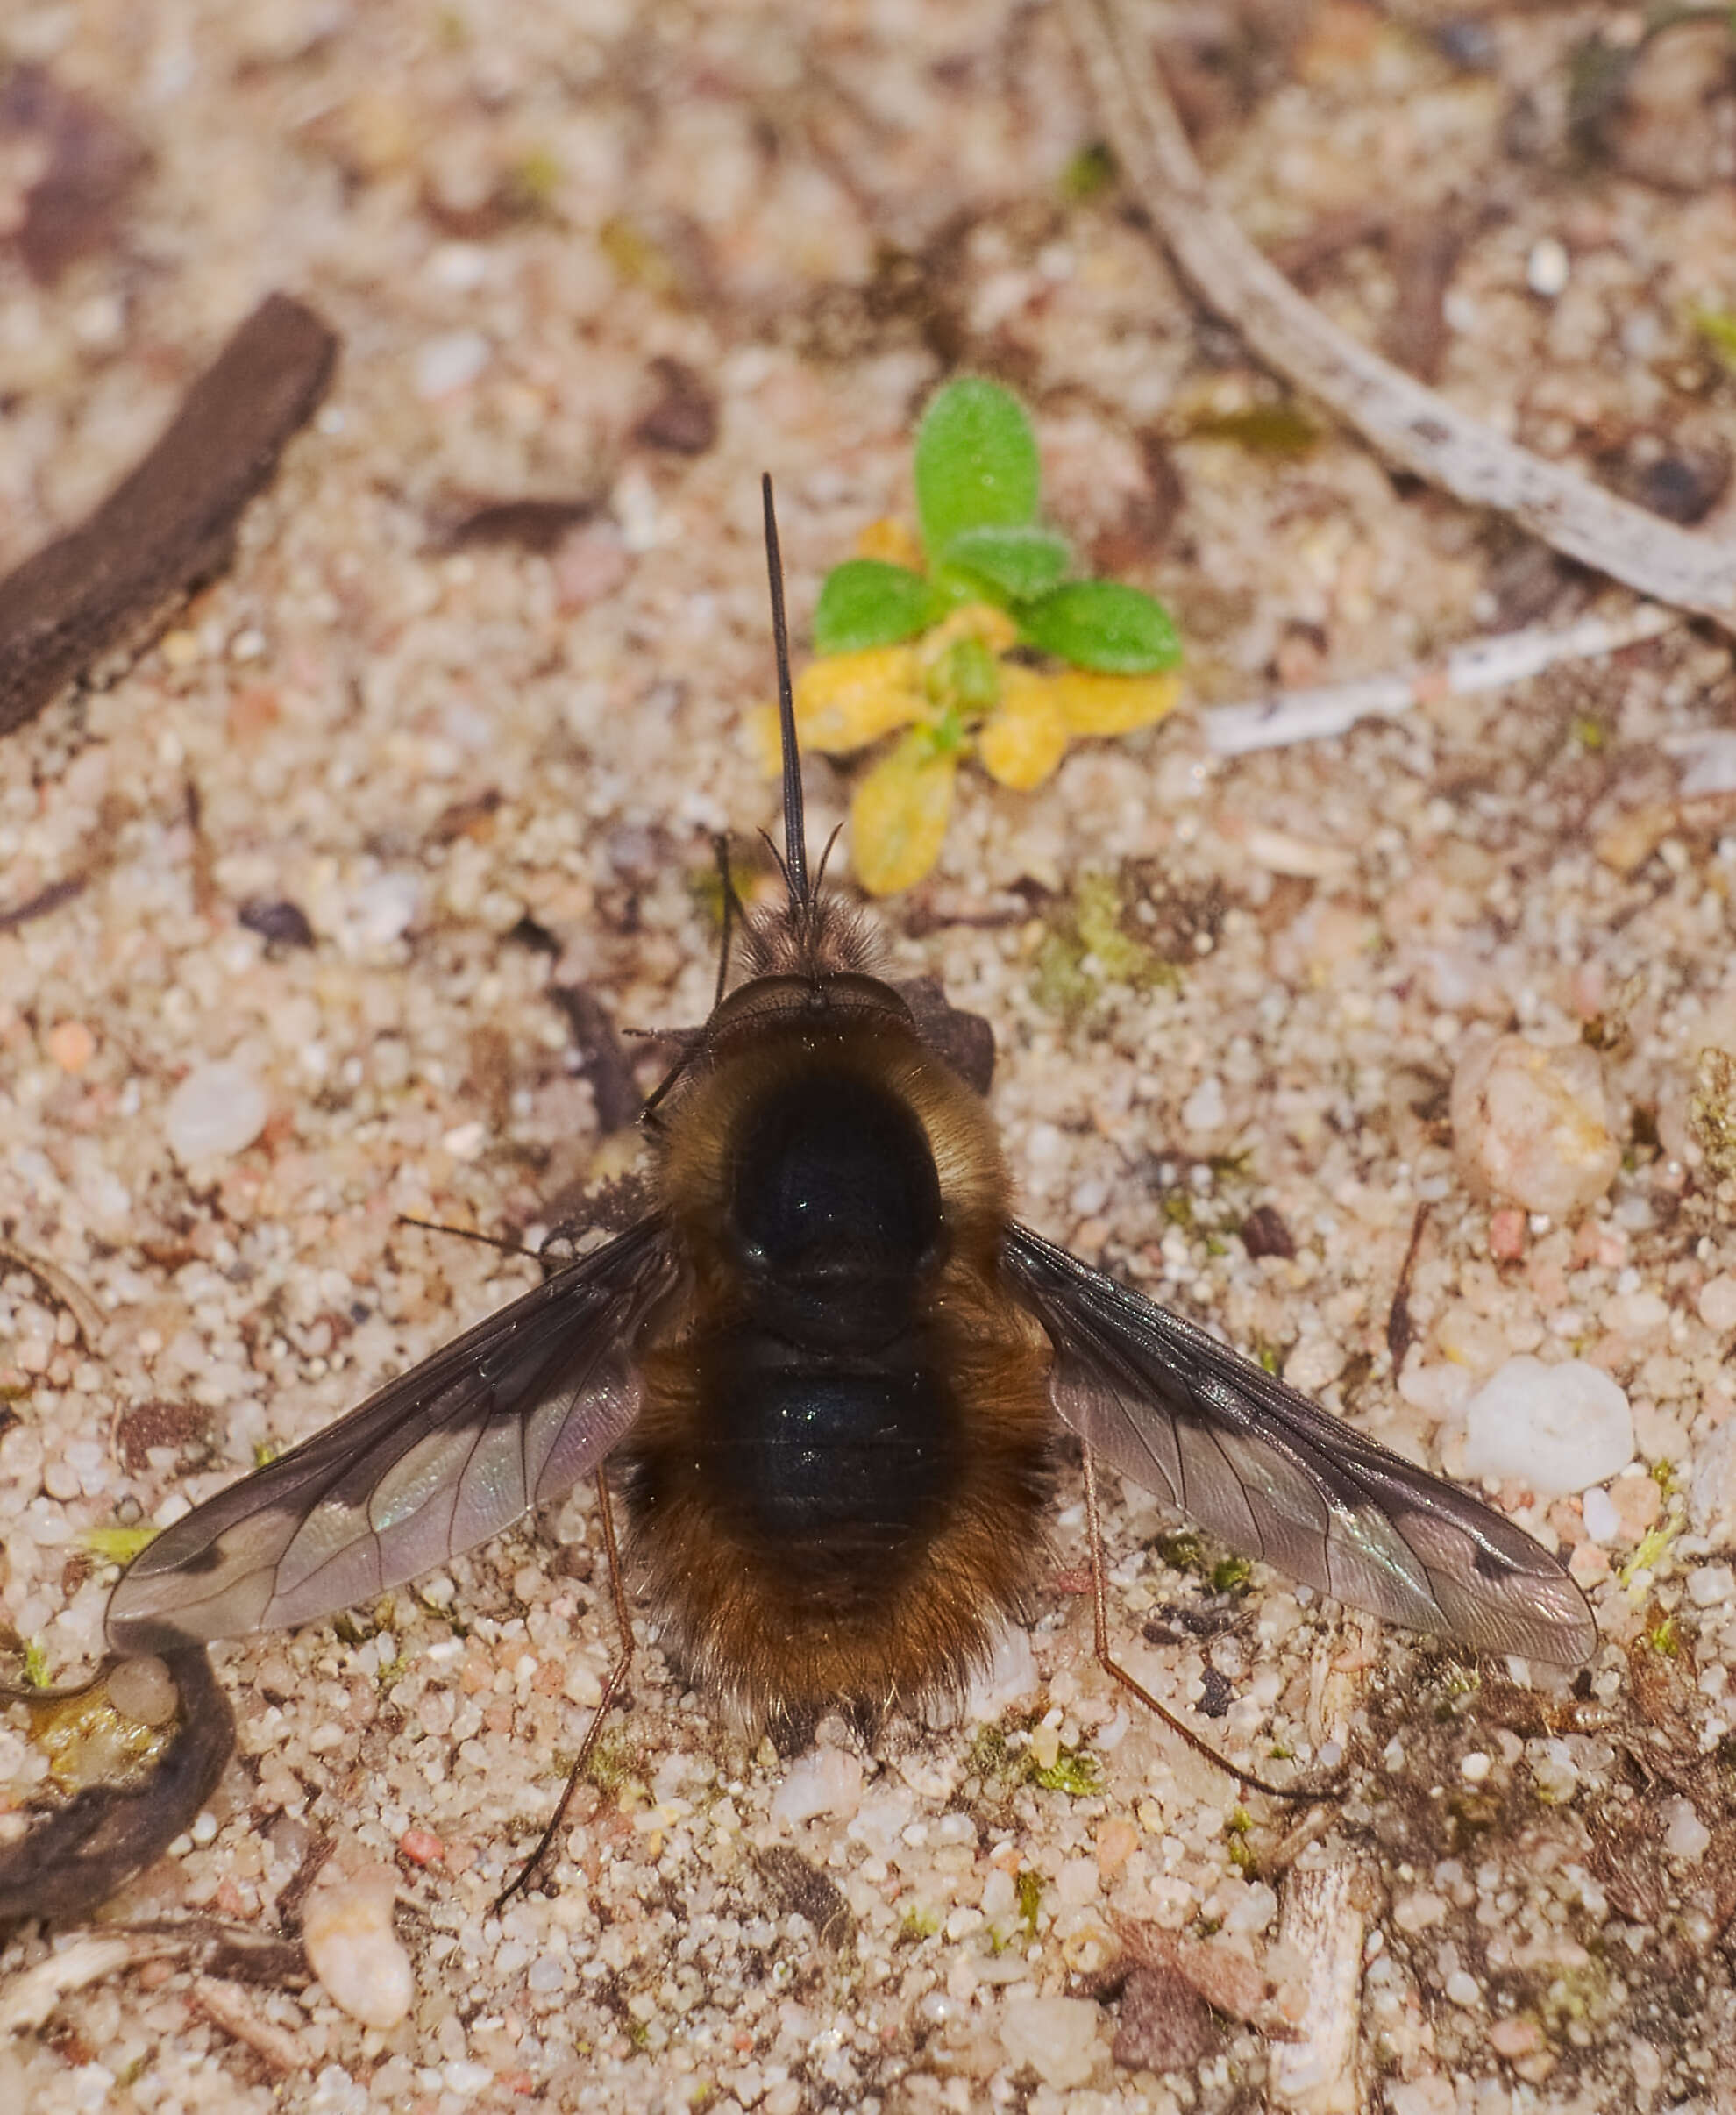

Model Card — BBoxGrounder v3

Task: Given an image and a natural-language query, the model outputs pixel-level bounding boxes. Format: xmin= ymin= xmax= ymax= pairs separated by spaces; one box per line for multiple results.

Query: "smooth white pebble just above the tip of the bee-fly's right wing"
xmin=1465 ymin=1351 xmax=1634 ymax=1498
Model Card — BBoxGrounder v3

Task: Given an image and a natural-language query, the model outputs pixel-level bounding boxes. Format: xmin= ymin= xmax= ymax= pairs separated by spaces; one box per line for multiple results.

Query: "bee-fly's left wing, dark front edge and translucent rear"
xmin=108 ymin=1221 xmax=677 ymax=1652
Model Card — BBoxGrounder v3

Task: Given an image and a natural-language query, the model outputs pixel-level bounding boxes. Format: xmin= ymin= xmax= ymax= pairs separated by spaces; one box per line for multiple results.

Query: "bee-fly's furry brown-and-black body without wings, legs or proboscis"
xmin=622 ymin=975 xmax=1051 ymax=1728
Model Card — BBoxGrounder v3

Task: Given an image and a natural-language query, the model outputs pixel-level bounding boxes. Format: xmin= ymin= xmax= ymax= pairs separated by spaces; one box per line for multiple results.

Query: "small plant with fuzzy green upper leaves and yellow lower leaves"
xmin=761 ymin=376 xmax=1182 ymax=894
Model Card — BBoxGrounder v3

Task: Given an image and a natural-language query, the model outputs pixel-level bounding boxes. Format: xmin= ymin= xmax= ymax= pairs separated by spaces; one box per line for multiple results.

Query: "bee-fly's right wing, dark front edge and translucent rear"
xmin=1002 ymin=1227 xmax=1597 ymax=1667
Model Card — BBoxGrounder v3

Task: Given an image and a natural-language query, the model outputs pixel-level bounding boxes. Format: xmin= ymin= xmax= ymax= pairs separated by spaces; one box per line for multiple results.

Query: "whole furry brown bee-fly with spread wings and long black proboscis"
xmin=108 ymin=481 xmax=1597 ymax=1869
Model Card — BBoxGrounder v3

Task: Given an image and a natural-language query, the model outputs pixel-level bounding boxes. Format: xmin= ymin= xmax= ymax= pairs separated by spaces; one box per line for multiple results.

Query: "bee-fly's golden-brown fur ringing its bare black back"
xmin=623 ymin=905 xmax=1053 ymax=1732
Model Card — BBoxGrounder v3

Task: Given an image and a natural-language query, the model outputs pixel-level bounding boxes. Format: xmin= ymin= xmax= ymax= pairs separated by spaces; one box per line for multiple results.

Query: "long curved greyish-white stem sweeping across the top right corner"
xmin=1064 ymin=0 xmax=1736 ymax=630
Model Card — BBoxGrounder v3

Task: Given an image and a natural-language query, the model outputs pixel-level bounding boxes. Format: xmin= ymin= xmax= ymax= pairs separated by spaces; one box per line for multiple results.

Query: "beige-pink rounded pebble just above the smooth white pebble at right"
xmin=1450 ymin=1036 xmax=1622 ymax=1214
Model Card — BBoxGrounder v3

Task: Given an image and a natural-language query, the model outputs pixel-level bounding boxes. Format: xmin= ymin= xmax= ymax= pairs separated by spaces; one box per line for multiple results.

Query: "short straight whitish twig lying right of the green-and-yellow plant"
xmin=1201 ymin=602 xmax=1688 ymax=757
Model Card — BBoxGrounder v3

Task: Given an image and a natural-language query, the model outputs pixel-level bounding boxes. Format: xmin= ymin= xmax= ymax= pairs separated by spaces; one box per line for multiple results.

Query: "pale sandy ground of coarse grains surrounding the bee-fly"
xmin=0 ymin=0 xmax=1736 ymax=2115
